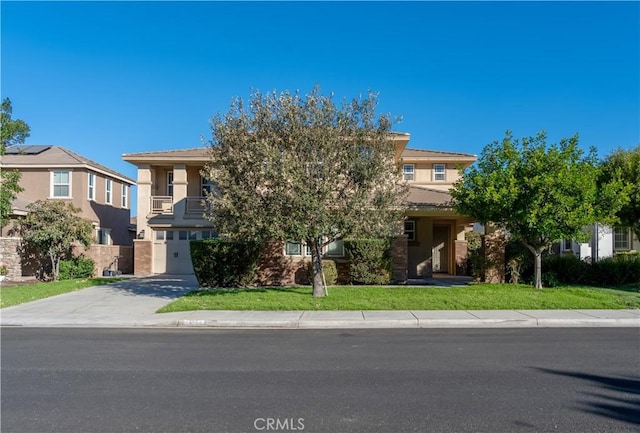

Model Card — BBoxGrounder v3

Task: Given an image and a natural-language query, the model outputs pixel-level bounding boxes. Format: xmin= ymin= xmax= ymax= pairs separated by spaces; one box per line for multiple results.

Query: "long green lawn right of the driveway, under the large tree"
xmin=158 ymin=284 xmax=640 ymax=313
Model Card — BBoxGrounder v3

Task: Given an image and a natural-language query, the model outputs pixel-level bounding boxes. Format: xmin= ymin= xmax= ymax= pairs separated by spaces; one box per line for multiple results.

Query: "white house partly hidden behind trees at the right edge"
xmin=553 ymin=224 xmax=640 ymax=260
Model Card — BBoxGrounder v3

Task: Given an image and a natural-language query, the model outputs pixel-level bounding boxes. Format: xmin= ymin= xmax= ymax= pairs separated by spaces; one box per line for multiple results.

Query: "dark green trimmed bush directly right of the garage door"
xmin=190 ymin=239 xmax=263 ymax=287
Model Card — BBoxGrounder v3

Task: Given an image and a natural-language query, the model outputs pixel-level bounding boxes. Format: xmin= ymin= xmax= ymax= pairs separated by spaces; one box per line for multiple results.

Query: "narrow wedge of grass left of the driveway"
xmin=0 ymin=278 xmax=123 ymax=308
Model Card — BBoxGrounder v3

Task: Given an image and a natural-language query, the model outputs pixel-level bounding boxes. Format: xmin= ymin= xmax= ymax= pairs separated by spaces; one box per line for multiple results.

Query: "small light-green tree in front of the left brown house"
xmin=19 ymin=200 xmax=94 ymax=280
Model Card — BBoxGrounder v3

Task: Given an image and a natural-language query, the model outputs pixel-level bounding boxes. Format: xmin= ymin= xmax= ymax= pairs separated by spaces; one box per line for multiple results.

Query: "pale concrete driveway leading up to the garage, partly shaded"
xmin=0 ymin=275 xmax=198 ymax=326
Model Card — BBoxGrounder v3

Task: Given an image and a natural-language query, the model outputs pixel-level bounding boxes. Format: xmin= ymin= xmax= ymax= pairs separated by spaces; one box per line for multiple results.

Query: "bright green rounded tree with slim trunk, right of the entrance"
xmin=451 ymin=131 xmax=616 ymax=289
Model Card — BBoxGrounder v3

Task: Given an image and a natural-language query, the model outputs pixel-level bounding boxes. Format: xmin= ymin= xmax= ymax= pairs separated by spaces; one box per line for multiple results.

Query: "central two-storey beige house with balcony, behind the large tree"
xmin=123 ymin=133 xmax=476 ymax=283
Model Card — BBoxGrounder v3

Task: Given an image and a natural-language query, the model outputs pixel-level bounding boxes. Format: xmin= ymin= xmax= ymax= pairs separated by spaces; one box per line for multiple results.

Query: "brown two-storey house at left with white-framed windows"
xmin=0 ymin=145 xmax=135 ymax=276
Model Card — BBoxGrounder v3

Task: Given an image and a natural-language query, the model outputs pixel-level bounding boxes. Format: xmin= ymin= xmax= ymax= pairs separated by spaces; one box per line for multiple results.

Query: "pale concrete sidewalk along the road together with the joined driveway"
xmin=0 ymin=275 xmax=640 ymax=329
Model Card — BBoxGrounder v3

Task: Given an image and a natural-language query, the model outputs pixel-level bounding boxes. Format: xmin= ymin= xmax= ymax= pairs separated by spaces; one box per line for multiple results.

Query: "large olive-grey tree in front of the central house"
xmin=204 ymin=87 xmax=406 ymax=296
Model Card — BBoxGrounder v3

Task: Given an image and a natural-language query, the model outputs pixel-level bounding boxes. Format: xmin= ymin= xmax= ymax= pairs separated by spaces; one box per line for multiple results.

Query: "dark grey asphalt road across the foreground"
xmin=1 ymin=328 xmax=640 ymax=433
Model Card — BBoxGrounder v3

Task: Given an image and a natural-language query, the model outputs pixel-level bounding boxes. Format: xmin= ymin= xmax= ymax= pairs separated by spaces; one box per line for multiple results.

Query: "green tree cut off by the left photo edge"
xmin=0 ymin=98 xmax=29 ymax=226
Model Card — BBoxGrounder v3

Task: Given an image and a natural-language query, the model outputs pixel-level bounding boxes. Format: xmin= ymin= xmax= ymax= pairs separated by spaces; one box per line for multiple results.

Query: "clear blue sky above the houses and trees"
xmin=0 ymin=1 xmax=640 ymax=213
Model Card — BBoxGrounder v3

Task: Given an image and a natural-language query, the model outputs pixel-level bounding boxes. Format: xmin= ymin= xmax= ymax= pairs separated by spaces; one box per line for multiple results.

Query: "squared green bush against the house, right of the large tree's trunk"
xmin=344 ymin=239 xmax=393 ymax=284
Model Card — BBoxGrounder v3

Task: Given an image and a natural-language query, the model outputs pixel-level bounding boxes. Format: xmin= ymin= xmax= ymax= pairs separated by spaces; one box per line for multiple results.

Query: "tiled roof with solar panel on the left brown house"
xmin=0 ymin=145 xmax=136 ymax=185
